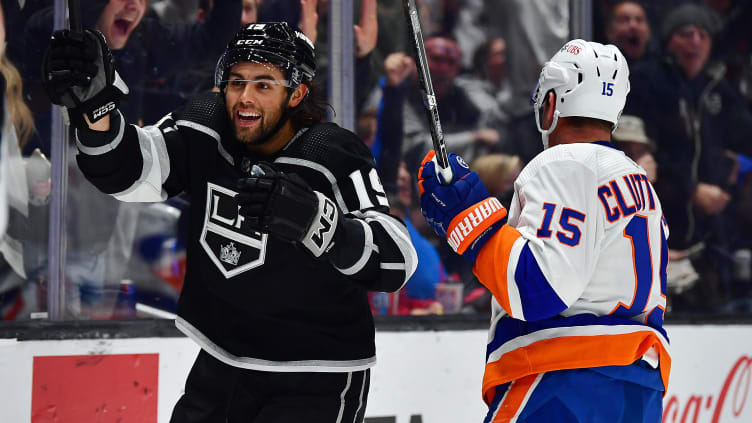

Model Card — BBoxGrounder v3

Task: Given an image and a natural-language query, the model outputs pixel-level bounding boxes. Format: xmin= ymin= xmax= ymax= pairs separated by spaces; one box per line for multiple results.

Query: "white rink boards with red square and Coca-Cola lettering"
xmin=0 ymin=324 xmax=752 ymax=423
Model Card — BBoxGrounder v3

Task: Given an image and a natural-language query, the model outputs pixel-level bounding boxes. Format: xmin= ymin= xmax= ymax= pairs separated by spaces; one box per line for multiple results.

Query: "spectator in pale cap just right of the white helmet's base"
xmin=611 ymin=115 xmax=657 ymax=183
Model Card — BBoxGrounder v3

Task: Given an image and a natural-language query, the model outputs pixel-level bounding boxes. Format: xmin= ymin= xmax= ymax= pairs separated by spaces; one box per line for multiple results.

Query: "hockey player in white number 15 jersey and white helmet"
xmin=419 ymin=40 xmax=671 ymax=423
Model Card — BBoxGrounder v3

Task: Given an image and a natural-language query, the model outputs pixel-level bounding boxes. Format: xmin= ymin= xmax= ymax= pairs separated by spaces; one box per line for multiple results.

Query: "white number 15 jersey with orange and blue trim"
xmin=474 ymin=142 xmax=670 ymax=400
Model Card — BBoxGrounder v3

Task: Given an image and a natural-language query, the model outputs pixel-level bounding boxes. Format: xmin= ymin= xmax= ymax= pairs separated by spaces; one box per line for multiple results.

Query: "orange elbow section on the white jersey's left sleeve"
xmin=473 ymin=225 xmax=522 ymax=317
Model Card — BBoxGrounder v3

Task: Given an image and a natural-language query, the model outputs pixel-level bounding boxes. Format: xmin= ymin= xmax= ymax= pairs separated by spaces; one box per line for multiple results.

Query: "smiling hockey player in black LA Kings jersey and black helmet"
xmin=43 ymin=23 xmax=417 ymax=423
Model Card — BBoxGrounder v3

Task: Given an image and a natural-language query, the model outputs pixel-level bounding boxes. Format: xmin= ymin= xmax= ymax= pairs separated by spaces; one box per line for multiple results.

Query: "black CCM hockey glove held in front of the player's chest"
xmin=236 ymin=163 xmax=339 ymax=257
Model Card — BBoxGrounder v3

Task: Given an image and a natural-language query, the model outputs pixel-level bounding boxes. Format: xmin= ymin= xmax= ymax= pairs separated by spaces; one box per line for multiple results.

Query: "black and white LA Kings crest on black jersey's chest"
xmin=200 ymin=182 xmax=268 ymax=279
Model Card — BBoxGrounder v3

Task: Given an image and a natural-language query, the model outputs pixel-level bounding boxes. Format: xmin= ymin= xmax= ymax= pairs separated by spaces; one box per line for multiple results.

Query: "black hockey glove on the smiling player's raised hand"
xmin=42 ymin=29 xmax=128 ymax=128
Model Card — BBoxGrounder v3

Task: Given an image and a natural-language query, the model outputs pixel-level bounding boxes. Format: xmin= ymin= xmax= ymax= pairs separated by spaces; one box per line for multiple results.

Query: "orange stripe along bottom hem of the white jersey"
xmin=483 ymin=330 xmax=671 ymax=402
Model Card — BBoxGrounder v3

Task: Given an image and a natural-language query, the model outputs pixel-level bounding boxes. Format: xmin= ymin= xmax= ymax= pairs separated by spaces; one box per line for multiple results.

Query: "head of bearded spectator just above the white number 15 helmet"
xmin=606 ymin=0 xmax=656 ymax=66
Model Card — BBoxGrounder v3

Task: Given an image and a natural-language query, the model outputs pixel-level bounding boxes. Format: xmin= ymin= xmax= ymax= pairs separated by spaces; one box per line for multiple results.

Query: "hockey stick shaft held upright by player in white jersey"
xmin=402 ymin=0 xmax=454 ymax=184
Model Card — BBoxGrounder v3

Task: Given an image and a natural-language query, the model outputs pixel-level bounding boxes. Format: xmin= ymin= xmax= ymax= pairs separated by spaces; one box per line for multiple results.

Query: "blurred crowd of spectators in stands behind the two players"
xmin=0 ymin=0 xmax=752 ymax=319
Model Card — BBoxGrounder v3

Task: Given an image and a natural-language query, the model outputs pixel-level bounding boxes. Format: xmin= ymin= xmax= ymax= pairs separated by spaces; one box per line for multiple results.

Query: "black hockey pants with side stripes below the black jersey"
xmin=170 ymin=350 xmax=370 ymax=423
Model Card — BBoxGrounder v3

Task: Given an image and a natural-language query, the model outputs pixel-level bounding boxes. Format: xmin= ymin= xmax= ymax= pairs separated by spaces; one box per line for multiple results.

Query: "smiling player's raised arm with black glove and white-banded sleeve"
xmin=43 ymin=30 xmax=186 ymax=201
